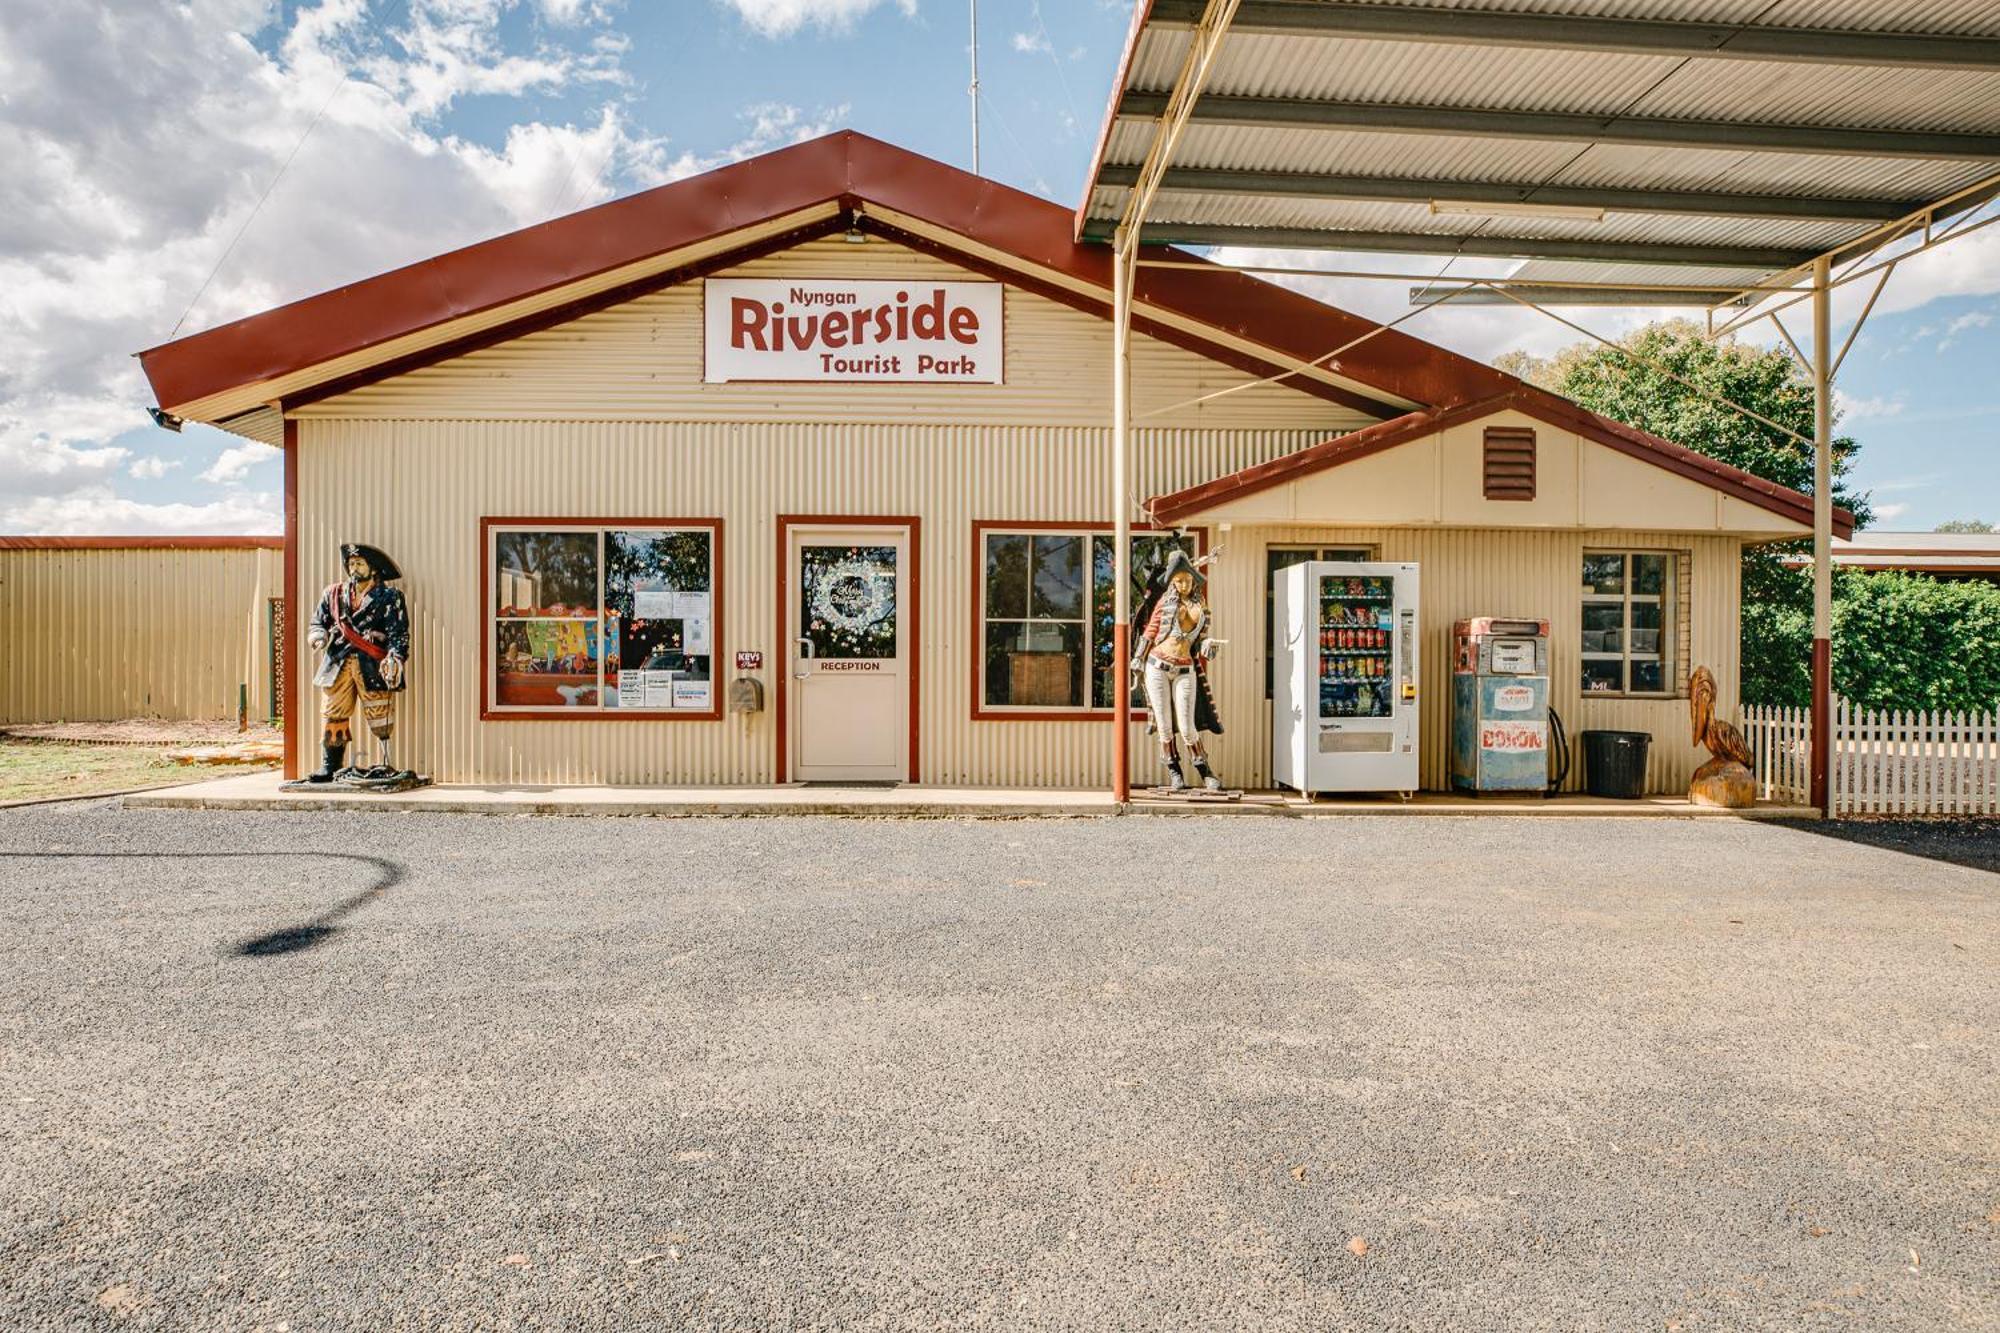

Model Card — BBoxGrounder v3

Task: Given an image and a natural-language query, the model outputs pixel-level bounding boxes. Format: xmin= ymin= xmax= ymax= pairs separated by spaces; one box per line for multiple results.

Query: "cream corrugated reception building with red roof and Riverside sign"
xmin=129 ymin=134 xmax=1840 ymax=789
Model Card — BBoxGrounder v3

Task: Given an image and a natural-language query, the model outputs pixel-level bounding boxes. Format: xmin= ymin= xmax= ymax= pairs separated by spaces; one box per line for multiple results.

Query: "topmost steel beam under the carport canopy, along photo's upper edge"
xmin=1148 ymin=0 xmax=2000 ymax=70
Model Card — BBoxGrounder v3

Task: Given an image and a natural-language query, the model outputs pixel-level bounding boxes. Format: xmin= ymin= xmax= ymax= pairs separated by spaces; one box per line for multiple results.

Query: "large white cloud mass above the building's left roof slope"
xmin=0 ymin=0 xmax=670 ymax=526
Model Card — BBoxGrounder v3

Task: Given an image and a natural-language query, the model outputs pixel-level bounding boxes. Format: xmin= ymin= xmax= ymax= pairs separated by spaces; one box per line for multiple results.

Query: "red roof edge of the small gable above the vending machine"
xmin=1146 ymin=384 xmax=1854 ymax=536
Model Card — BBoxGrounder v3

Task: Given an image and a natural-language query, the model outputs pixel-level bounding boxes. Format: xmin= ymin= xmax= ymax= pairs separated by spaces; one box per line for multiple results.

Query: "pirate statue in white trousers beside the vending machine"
xmin=1132 ymin=546 xmax=1222 ymax=793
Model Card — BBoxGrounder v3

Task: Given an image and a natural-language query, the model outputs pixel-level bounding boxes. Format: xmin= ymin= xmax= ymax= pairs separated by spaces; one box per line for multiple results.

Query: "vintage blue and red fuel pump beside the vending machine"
xmin=1452 ymin=616 xmax=1568 ymax=793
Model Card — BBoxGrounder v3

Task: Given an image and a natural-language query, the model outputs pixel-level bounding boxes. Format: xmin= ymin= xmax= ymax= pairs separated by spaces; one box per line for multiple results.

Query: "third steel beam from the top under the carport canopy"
xmin=1098 ymin=164 xmax=1926 ymax=222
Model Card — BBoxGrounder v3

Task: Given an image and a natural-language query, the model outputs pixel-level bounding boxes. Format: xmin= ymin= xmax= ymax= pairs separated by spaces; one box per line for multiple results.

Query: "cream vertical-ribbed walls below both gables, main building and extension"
xmin=300 ymin=422 xmax=1740 ymax=791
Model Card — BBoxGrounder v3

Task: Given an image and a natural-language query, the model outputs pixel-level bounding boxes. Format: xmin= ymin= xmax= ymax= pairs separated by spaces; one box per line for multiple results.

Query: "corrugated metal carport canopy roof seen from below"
xmin=1078 ymin=0 xmax=2000 ymax=304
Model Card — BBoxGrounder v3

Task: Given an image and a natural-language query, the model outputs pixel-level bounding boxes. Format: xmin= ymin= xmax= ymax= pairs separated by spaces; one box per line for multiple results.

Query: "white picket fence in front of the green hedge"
xmin=1742 ymin=699 xmax=2000 ymax=815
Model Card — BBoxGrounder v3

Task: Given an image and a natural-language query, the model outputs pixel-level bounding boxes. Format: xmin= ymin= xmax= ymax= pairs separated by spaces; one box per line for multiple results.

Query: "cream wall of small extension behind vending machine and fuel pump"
xmin=1214 ymin=526 xmax=1742 ymax=791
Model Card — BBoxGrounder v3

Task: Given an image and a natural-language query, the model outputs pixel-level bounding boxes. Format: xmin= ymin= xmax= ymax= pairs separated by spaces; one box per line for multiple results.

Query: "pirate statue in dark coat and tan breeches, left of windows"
xmin=292 ymin=542 xmax=420 ymax=791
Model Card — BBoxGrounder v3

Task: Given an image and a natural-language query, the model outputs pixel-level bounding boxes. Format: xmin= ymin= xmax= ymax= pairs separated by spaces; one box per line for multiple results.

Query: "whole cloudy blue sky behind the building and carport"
xmin=0 ymin=0 xmax=2000 ymax=532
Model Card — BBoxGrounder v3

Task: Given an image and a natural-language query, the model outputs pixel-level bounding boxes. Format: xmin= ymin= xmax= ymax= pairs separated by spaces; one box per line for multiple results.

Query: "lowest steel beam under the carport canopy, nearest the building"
xmin=1084 ymin=222 xmax=1816 ymax=268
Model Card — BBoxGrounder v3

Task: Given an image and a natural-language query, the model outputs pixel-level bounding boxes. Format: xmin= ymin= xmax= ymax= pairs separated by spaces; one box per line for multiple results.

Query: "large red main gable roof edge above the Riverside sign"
xmin=140 ymin=130 xmax=1518 ymax=414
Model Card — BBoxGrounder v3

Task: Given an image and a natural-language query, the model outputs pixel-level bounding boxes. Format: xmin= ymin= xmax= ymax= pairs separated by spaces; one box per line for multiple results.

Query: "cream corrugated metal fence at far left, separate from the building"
xmin=0 ymin=546 xmax=284 ymax=723
